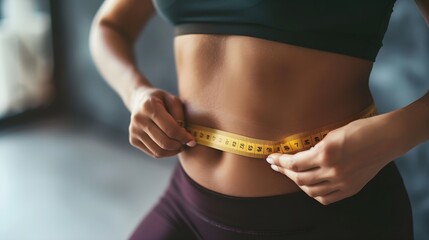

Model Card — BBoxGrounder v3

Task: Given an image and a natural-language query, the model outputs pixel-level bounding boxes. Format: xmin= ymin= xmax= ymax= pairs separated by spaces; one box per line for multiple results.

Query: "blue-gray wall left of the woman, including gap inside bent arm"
xmin=56 ymin=0 xmax=177 ymax=132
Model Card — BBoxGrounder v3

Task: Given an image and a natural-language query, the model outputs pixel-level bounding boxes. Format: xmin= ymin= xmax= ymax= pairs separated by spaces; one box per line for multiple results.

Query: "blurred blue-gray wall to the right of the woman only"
xmin=371 ymin=0 xmax=429 ymax=239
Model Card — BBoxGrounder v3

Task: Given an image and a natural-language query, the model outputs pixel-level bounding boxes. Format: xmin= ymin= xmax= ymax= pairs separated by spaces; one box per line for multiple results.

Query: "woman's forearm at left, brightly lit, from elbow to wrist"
xmin=90 ymin=21 xmax=151 ymax=109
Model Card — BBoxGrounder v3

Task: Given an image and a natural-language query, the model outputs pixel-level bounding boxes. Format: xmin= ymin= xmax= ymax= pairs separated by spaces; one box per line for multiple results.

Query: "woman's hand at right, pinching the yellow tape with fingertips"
xmin=267 ymin=114 xmax=402 ymax=205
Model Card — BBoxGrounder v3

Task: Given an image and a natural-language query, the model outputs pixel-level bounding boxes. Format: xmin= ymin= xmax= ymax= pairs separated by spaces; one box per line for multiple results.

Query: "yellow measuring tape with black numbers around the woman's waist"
xmin=181 ymin=104 xmax=377 ymax=158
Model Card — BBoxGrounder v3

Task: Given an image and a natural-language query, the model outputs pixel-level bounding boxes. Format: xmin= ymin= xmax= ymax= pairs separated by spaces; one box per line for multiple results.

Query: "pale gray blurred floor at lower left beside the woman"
xmin=0 ymin=116 xmax=176 ymax=240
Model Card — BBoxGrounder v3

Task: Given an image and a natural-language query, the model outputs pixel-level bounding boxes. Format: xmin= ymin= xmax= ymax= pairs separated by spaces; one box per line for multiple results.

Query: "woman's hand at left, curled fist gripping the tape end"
xmin=129 ymin=87 xmax=196 ymax=158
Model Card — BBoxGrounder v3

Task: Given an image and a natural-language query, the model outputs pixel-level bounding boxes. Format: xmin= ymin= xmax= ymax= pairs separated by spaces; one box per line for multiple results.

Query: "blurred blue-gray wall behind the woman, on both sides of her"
xmin=56 ymin=0 xmax=429 ymax=239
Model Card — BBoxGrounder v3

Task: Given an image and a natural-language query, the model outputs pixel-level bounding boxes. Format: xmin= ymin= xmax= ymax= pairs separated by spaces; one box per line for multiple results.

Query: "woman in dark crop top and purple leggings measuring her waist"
xmin=90 ymin=0 xmax=429 ymax=239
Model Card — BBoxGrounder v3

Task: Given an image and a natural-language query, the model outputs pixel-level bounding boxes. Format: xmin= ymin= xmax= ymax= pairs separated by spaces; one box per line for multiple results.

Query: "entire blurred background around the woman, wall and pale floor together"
xmin=0 ymin=0 xmax=429 ymax=240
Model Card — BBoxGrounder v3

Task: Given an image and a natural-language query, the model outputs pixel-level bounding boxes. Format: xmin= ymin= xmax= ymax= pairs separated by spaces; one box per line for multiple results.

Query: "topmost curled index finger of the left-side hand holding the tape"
xmin=152 ymin=98 xmax=195 ymax=147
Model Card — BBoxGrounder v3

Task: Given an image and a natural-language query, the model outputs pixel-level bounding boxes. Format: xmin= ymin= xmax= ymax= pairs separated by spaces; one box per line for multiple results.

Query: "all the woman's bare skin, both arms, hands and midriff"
xmin=90 ymin=0 xmax=429 ymax=204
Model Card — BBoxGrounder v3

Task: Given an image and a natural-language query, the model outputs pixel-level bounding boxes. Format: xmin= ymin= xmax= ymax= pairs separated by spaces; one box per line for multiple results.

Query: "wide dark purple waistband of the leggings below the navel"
xmin=167 ymin=162 xmax=403 ymax=230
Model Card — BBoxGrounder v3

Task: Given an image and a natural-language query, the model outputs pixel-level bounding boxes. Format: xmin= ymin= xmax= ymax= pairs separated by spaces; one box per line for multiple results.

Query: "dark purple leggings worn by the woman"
xmin=130 ymin=163 xmax=413 ymax=240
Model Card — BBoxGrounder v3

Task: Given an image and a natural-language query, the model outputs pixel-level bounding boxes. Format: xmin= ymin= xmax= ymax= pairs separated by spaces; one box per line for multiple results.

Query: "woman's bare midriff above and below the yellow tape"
xmin=174 ymin=34 xmax=373 ymax=197
